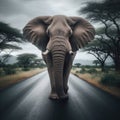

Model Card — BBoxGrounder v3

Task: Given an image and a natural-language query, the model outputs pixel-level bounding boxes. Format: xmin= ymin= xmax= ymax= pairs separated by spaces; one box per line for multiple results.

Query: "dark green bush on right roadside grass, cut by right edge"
xmin=101 ymin=74 xmax=120 ymax=87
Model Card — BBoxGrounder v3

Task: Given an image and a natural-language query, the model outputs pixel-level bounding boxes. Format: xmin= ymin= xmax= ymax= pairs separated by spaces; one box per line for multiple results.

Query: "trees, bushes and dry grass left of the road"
xmin=0 ymin=54 xmax=46 ymax=89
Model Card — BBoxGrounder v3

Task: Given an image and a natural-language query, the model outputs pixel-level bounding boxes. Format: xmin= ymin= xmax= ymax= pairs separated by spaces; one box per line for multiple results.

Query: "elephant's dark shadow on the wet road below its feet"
xmin=39 ymin=99 xmax=80 ymax=120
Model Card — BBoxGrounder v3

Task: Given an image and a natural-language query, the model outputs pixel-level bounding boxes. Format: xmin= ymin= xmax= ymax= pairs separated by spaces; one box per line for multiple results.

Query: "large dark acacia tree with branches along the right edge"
xmin=80 ymin=0 xmax=120 ymax=71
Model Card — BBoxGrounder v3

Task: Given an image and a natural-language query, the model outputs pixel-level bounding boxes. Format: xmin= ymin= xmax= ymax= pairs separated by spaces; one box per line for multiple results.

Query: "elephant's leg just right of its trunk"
xmin=63 ymin=53 xmax=76 ymax=94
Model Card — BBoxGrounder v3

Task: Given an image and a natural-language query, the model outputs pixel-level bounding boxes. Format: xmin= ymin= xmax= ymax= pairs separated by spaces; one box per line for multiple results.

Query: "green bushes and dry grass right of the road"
xmin=71 ymin=65 xmax=120 ymax=97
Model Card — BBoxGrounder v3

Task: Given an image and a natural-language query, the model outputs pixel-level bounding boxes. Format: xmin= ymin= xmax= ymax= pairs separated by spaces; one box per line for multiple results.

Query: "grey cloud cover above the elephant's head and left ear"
xmin=0 ymin=0 xmax=75 ymax=30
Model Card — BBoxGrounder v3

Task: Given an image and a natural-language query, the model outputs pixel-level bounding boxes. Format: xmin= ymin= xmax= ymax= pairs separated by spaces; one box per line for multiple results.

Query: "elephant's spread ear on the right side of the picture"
xmin=69 ymin=17 xmax=95 ymax=51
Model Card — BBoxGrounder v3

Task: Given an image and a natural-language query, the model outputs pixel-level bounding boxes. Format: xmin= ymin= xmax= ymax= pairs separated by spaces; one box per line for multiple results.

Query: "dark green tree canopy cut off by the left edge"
xmin=0 ymin=22 xmax=22 ymax=52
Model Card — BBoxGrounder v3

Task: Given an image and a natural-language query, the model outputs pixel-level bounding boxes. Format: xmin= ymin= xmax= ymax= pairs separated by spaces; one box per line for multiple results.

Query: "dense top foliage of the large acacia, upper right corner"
xmin=79 ymin=0 xmax=120 ymax=22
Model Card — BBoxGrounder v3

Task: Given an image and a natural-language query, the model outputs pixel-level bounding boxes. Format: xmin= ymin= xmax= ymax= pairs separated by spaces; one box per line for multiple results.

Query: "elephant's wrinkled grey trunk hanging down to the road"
xmin=52 ymin=46 xmax=66 ymax=97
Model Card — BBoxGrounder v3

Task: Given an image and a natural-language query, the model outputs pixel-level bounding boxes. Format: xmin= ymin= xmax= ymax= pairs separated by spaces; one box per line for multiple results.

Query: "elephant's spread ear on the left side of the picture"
xmin=23 ymin=16 xmax=51 ymax=51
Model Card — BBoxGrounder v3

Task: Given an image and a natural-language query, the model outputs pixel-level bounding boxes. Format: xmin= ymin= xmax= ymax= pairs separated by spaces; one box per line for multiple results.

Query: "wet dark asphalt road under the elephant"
xmin=0 ymin=72 xmax=120 ymax=120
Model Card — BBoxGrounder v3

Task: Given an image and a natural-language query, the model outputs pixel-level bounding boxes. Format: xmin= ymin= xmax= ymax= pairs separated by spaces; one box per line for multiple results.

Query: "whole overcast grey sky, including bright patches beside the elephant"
xmin=0 ymin=0 xmax=101 ymax=59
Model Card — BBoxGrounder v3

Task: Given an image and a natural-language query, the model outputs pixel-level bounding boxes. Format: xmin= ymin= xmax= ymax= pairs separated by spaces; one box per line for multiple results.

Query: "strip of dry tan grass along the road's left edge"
xmin=0 ymin=68 xmax=45 ymax=89
